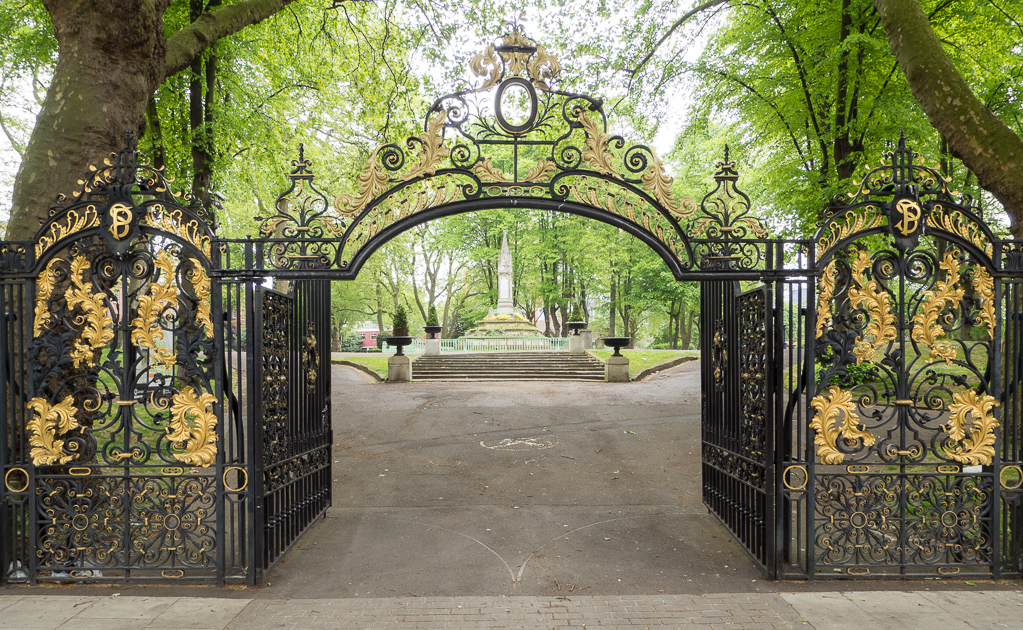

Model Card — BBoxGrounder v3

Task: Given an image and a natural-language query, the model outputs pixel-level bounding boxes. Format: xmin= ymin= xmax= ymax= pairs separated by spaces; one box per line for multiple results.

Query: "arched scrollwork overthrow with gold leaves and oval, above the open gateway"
xmin=258 ymin=26 xmax=766 ymax=276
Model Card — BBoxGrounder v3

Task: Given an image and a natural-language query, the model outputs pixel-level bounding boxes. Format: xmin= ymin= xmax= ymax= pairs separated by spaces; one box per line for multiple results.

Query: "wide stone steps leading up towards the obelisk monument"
xmin=412 ymin=351 xmax=604 ymax=380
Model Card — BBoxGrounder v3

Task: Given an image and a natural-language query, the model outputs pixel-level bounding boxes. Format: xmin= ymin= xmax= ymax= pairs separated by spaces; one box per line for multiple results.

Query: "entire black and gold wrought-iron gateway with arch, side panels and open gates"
xmin=0 ymin=28 xmax=1023 ymax=583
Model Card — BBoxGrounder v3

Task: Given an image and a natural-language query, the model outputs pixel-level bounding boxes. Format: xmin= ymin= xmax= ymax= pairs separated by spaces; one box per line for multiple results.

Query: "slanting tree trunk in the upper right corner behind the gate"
xmin=874 ymin=0 xmax=1023 ymax=237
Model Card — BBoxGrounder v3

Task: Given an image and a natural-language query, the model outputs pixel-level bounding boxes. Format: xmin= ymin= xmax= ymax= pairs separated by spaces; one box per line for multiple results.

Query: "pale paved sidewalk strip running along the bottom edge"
xmin=0 ymin=591 xmax=1023 ymax=630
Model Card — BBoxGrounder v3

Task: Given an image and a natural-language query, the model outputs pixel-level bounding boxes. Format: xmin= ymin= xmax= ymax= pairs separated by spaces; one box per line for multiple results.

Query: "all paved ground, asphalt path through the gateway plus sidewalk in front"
xmin=0 ymin=362 xmax=1023 ymax=630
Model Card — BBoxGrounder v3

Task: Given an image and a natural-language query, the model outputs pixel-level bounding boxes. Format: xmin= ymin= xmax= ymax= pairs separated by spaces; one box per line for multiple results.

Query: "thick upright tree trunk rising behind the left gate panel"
xmin=7 ymin=0 xmax=166 ymax=239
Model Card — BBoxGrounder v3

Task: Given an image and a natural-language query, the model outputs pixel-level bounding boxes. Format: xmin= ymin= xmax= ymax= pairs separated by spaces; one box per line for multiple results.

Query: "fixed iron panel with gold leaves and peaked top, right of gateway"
xmin=810 ymin=138 xmax=999 ymax=566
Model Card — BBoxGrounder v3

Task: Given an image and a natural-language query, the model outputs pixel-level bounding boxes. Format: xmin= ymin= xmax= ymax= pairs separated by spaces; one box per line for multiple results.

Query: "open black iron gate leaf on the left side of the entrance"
xmin=252 ymin=280 xmax=333 ymax=581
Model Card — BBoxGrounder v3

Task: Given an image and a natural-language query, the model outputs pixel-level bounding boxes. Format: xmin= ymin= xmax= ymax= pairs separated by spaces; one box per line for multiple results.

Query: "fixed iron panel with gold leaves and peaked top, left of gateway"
xmin=26 ymin=139 xmax=219 ymax=577
